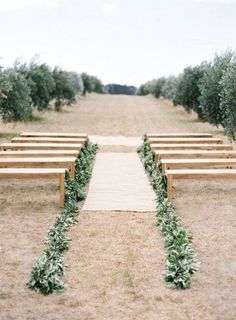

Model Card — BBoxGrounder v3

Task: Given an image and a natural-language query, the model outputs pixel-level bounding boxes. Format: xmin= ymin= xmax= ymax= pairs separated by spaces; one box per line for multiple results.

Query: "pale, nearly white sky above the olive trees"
xmin=0 ymin=0 xmax=236 ymax=86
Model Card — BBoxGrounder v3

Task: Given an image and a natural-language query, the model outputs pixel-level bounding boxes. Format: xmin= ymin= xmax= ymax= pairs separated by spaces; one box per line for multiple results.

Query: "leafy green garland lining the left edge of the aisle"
xmin=28 ymin=140 xmax=98 ymax=295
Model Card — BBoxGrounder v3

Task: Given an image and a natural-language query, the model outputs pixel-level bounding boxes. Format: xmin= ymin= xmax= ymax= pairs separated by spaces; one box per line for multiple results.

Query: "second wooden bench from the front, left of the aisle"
xmin=0 ymin=157 xmax=76 ymax=178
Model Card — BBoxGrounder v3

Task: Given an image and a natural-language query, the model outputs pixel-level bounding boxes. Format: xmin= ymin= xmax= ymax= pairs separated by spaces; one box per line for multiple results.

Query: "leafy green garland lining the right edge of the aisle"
xmin=138 ymin=137 xmax=198 ymax=289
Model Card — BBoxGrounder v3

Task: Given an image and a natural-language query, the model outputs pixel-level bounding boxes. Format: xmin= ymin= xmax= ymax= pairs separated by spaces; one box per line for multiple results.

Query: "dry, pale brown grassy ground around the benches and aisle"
xmin=0 ymin=95 xmax=236 ymax=320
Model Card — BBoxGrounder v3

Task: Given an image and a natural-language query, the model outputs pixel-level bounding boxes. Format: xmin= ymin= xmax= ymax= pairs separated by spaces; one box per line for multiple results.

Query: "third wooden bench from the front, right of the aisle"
xmin=154 ymin=150 xmax=236 ymax=160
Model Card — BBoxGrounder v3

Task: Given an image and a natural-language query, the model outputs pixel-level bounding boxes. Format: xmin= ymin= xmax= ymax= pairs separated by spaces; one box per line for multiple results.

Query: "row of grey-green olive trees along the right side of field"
xmin=138 ymin=51 xmax=236 ymax=141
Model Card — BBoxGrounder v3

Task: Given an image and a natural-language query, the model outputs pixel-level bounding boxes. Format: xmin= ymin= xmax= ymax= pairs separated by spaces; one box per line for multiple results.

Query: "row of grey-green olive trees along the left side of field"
xmin=0 ymin=59 xmax=103 ymax=122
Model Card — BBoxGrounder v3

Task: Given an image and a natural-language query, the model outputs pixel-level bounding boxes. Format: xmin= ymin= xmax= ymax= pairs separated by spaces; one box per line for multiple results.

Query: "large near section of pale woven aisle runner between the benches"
xmin=83 ymin=153 xmax=155 ymax=212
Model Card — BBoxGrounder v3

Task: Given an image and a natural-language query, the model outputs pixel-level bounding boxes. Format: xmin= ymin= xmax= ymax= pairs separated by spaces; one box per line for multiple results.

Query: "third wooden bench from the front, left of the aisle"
xmin=0 ymin=150 xmax=79 ymax=158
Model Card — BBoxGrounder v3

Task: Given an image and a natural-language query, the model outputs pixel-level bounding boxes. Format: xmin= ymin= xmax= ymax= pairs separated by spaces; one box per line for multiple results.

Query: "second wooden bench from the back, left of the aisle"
xmin=11 ymin=137 xmax=86 ymax=145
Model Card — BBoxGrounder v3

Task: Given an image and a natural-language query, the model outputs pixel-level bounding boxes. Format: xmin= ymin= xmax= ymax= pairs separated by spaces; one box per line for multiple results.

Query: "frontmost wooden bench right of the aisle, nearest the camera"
xmin=165 ymin=169 xmax=236 ymax=200
